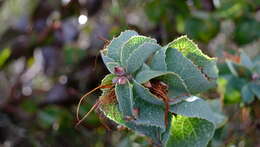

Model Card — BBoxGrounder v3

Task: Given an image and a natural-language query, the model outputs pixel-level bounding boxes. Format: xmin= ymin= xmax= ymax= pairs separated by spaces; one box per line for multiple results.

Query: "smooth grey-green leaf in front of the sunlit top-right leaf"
xmin=166 ymin=48 xmax=215 ymax=94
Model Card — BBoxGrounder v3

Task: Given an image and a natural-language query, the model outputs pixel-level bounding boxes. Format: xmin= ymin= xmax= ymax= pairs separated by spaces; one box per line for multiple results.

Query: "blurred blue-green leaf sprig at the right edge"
xmin=219 ymin=51 xmax=260 ymax=104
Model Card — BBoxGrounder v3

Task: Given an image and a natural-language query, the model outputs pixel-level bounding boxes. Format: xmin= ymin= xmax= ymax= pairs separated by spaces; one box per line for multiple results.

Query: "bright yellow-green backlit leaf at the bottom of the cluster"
xmin=167 ymin=115 xmax=215 ymax=147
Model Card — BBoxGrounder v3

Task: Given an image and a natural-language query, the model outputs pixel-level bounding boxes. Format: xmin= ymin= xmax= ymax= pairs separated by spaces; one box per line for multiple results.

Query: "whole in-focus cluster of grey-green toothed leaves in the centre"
xmin=100 ymin=30 xmax=225 ymax=146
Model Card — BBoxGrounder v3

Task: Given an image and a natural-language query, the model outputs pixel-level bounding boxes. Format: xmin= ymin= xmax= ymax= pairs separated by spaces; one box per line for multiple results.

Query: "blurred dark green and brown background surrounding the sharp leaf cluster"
xmin=0 ymin=0 xmax=260 ymax=147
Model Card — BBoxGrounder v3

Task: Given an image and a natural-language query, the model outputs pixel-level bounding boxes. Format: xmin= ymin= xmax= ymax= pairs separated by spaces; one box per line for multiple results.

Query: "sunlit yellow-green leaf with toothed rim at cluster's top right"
xmin=168 ymin=36 xmax=218 ymax=80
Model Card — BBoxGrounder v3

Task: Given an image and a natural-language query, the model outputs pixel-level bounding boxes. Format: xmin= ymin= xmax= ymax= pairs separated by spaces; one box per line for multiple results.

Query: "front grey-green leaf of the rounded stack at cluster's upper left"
xmin=126 ymin=42 xmax=161 ymax=73
